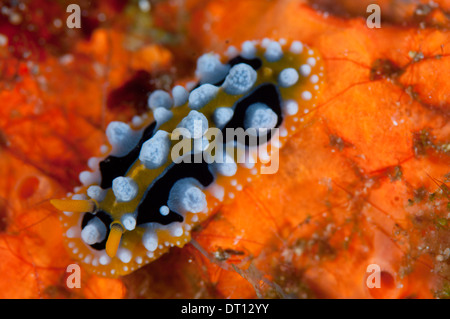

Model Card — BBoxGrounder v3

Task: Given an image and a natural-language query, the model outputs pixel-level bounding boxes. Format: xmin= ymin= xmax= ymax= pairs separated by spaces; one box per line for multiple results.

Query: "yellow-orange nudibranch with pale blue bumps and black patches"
xmin=52 ymin=39 xmax=324 ymax=277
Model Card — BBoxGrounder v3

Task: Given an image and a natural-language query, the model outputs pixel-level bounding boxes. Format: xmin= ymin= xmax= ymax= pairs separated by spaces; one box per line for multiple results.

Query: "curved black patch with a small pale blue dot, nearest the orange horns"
xmin=136 ymin=154 xmax=214 ymax=225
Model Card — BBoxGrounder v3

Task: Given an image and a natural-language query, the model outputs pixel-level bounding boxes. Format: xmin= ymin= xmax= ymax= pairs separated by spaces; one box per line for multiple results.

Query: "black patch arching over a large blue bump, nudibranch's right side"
xmin=222 ymin=83 xmax=283 ymax=146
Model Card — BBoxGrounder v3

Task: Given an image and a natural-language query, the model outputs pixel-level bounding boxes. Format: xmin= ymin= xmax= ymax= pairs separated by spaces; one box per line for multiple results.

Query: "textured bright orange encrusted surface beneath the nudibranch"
xmin=0 ymin=0 xmax=450 ymax=298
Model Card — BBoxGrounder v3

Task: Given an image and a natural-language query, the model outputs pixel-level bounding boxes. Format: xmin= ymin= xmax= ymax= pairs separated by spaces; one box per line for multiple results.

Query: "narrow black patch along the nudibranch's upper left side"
xmin=100 ymin=122 xmax=156 ymax=189
